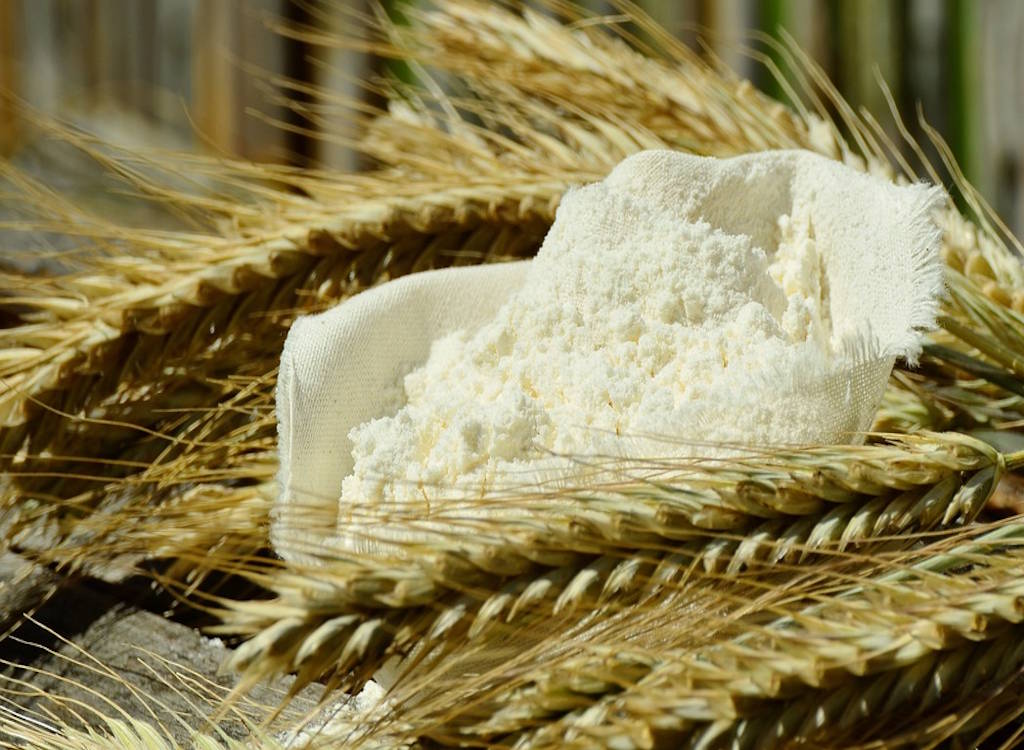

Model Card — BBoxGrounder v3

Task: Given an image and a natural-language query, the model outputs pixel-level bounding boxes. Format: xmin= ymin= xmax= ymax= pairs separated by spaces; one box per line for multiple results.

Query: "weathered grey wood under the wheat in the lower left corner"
xmin=0 ymin=552 xmax=316 ymax=746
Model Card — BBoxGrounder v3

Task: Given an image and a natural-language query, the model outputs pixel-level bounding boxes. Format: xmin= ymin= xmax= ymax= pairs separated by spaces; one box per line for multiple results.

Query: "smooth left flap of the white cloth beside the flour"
xmin=270 ymin=261 xmax=529 ymax=564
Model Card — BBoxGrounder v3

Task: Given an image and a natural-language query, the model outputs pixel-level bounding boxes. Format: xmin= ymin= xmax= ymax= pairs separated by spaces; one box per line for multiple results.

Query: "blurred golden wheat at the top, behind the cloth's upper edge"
xmin=348 ymin=0 xmax=1024 ymax=290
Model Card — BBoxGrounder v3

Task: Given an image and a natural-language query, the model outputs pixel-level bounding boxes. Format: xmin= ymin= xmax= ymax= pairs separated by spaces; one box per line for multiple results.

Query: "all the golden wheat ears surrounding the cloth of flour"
xmin=6 ymin=1 xmax=1024 ymax=747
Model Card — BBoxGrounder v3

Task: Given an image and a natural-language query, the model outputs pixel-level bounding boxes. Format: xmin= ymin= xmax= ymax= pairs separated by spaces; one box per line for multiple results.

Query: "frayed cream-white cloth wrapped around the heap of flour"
xmin=271 ymin=151 xmax=943 ymax=564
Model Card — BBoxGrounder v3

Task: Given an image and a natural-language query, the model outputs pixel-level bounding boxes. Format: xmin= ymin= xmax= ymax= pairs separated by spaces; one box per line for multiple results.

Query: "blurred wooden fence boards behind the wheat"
xmin=0 ymin=0 xmax=1024 ymax=237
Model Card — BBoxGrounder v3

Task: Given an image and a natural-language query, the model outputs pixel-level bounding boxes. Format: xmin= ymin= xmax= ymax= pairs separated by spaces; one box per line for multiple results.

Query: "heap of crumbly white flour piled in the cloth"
xmin=341 ymin=176 xmax=843 ymax=508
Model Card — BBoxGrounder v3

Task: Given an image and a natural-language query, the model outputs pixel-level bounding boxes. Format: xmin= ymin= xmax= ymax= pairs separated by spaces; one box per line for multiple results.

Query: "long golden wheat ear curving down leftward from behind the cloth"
xmin=0 ymin=175 xmax=565 ymax=428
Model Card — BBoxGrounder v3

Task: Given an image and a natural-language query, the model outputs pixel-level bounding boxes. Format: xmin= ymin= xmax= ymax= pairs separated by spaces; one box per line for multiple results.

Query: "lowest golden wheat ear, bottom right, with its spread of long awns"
xmin=327 ymin=524 xmax=1021 ymax=747
